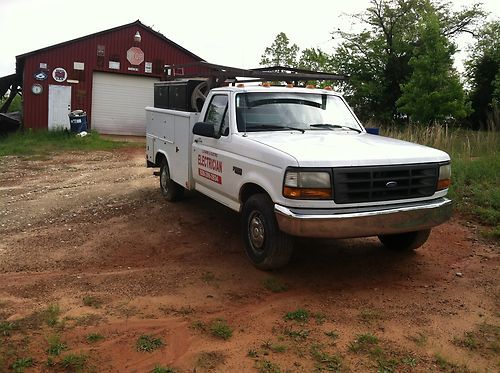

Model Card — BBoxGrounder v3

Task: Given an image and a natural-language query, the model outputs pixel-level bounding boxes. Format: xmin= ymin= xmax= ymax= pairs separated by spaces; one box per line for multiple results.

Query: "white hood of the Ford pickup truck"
xmin=248 ymin=131 xmax=450 ymax=167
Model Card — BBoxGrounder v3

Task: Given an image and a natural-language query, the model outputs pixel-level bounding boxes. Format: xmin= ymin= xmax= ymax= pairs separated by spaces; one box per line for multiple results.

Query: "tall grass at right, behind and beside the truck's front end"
xmin=380 ymin=125 xmax=500 ymax=238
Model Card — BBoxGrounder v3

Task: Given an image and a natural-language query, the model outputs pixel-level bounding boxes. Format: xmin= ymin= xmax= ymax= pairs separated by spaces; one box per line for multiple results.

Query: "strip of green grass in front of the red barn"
xmin=0 ymin=130 xmax=130 ymax=156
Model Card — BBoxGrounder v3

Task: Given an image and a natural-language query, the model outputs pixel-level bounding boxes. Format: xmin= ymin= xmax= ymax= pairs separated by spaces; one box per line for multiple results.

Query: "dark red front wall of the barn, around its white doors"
xmin=23 ymin=24 xmax=199 ymax=129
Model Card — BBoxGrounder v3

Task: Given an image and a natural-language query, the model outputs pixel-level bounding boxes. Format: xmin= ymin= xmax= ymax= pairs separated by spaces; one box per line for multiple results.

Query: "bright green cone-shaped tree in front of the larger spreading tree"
xmin=397 ymin=11 xmax=467 ymax=124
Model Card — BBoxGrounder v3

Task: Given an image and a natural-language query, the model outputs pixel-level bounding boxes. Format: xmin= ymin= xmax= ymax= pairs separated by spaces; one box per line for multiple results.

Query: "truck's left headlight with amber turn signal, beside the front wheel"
xmin=283 ymin=170 xmax=332 ymax=199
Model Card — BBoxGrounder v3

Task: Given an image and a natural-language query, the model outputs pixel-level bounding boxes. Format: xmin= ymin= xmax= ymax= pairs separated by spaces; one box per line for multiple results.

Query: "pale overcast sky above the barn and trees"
xmin=0 ymin=0 xmax=500 ymax=77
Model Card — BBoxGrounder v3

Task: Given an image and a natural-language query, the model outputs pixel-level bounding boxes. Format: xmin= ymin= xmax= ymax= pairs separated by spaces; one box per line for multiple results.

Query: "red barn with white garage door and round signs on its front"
xmin=16 ymin=20 xmax=203 ymax=135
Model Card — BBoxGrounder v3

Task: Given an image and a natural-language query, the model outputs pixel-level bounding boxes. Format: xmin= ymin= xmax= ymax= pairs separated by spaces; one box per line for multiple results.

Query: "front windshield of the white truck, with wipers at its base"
xmin=236 ymin=92 xmax=362 ymax=132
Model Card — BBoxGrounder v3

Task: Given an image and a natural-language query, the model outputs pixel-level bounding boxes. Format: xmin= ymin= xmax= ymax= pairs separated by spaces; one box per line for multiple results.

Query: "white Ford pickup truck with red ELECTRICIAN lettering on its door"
xmin=146 ymin=85 xmax=452 ymax=269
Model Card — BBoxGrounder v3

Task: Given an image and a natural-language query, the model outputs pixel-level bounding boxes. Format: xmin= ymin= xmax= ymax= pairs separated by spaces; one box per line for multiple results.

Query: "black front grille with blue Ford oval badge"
xmin=333 ymin=164 xmax=439 ymax=203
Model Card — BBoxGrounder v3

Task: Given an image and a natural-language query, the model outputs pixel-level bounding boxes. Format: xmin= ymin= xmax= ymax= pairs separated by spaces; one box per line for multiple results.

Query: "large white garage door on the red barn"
xmin=91 ymin=72 xmax=158 ymax=136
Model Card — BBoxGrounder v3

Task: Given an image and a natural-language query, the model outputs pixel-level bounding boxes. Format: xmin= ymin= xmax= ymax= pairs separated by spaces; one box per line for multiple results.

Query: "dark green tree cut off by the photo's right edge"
xmin=465 ymin=20 xmax=500 ymax=129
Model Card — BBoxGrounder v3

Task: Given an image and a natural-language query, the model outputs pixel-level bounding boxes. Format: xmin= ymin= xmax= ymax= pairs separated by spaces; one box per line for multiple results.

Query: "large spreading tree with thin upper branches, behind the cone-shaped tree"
xmin=333 ymin=0 xmax=484 ymax=122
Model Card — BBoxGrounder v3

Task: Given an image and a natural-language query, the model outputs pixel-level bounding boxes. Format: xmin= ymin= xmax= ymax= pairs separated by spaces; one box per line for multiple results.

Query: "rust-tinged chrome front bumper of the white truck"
xmin=274 ymin=198 xmax=453 ymax=238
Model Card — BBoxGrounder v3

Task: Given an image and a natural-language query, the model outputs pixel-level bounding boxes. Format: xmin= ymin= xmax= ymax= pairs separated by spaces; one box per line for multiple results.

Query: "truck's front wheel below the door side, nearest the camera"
xmin=242 ymin=194 xmax=293 ymax=270
